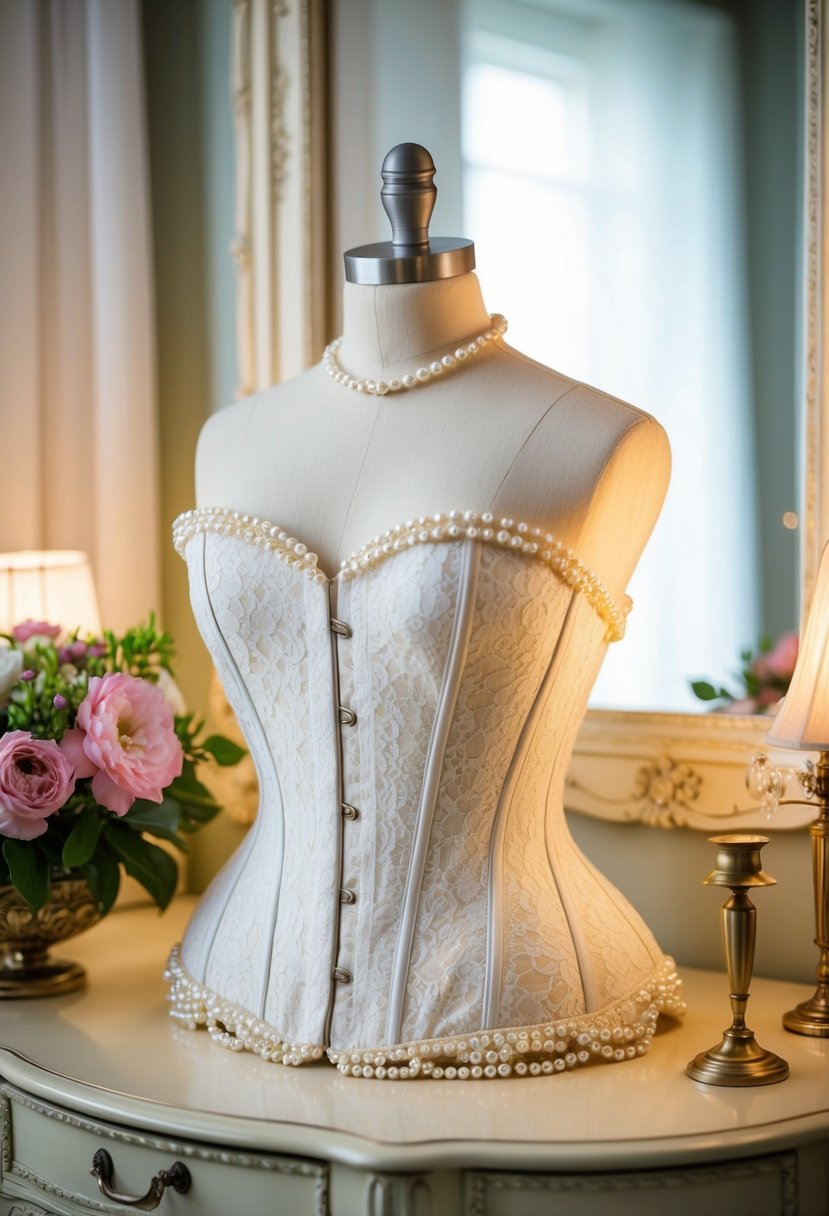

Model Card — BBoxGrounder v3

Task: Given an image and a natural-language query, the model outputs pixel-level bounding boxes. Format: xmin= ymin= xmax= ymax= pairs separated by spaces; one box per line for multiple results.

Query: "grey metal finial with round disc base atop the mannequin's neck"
xmin=345 ymin=143 xmax=475 ymax=285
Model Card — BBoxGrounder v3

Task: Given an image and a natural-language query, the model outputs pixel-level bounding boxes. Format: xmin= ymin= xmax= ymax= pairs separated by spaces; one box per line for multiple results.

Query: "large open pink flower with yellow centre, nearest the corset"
xmin=61 ymin=671 xmax=184 ymax=815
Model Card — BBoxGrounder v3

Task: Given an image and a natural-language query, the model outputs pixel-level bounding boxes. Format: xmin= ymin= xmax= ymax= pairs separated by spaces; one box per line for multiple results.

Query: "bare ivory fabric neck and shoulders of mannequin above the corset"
xmin=196 ymin=144 xmax=670 ymax=608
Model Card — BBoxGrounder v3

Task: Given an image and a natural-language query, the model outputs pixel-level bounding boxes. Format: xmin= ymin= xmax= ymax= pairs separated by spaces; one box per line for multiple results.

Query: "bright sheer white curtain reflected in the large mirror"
xmin=462 ymin=0 xmax=760 ymax=709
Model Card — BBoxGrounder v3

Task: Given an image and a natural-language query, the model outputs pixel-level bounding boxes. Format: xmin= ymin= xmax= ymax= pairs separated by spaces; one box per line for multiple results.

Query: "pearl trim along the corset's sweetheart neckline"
xmin=173 ymin=507 xmax=630 ymax=642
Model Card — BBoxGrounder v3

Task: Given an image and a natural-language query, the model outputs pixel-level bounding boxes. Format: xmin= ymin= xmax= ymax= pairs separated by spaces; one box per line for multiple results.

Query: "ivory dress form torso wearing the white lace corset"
xmin=169 ymin=272 xmax=681 ymax=1079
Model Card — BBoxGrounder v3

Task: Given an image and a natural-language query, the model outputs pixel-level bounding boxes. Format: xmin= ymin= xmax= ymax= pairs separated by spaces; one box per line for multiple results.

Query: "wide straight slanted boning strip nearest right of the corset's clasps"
xmin=385 ymin=540 xmax=480 ymax=1043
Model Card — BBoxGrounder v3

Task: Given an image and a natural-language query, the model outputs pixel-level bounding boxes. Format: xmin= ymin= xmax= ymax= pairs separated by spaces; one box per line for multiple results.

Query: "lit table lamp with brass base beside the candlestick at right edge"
xmin=766 ymin=545 xmax=829 ymax=1037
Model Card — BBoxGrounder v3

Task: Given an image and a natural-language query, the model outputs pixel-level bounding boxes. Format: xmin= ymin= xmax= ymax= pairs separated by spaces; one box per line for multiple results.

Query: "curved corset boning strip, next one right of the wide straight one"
xmin=481 ymin=591 xmax=577 ymax=1028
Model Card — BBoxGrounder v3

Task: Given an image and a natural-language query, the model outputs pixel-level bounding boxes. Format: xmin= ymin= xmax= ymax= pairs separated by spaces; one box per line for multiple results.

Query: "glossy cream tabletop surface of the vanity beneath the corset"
xmin=0 ymin=897 xmax=829 ymax=1170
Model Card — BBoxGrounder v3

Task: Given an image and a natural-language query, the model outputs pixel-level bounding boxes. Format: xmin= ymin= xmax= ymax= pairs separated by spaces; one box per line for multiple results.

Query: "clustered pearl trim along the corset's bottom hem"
xmin=164 ymin=946 xmax=686 ymax=1081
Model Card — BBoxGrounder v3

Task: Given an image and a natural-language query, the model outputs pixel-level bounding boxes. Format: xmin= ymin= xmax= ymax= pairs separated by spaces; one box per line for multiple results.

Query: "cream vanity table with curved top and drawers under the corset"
xmin=0 ymin=897 xmax=829 ymax=1216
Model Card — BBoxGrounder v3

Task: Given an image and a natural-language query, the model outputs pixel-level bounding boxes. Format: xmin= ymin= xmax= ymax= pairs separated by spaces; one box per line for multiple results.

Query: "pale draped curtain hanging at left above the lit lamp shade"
xmin=0 ymin=0 xmax=159 ymax=630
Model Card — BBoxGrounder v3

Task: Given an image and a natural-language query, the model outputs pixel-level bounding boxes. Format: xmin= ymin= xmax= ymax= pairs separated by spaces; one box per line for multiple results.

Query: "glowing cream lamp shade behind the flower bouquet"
xmin=0 ymin=548 xmax=101 ymax=634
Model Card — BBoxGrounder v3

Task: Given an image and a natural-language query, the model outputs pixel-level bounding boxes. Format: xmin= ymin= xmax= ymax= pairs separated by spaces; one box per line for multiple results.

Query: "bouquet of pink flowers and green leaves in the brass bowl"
xmin=0 ymin=617 xmax=244 ymax=914
